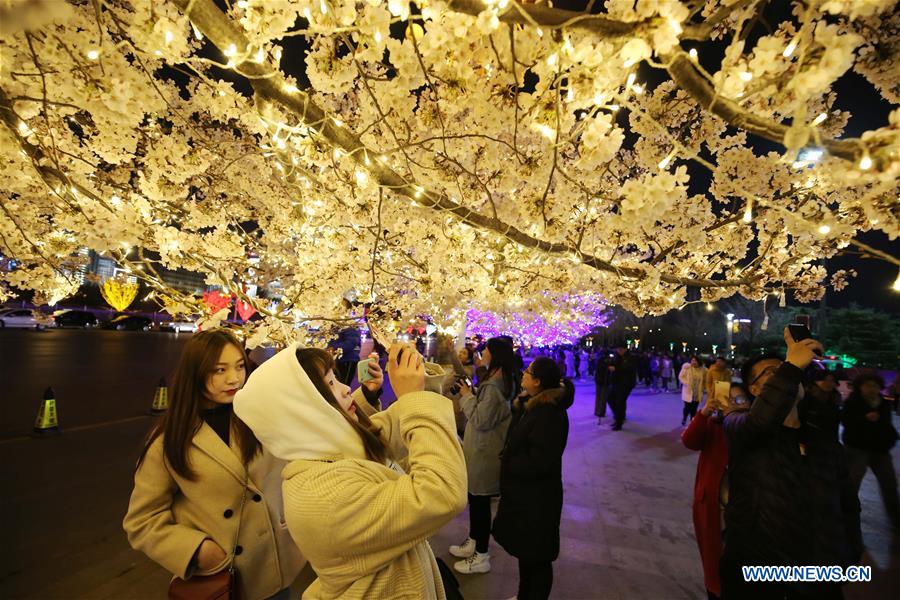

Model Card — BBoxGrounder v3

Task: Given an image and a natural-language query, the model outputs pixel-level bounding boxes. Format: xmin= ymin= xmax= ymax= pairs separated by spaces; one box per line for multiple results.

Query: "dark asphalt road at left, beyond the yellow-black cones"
xmin=0 ymin=329 xmax=189 ymax=440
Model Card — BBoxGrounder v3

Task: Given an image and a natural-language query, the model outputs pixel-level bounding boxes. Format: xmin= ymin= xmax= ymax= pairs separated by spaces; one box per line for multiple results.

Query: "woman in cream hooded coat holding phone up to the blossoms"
xmin=234 ymin=344 xmax=466 ymax=600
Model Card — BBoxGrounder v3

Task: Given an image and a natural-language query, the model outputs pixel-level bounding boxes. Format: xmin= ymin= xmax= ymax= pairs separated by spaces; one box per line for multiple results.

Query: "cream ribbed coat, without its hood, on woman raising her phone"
xmin=283 ymin=392 xmax=467 ymax=600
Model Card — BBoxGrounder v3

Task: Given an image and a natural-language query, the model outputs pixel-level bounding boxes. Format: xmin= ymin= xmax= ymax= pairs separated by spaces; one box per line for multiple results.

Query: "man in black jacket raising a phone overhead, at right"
xmin=720 ymin=329 xmax=862 ymax=600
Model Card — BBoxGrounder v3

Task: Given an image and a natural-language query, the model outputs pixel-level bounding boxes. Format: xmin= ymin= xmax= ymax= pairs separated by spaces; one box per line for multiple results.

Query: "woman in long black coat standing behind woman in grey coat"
xmin=493 ymin=357 xmax=575 ymax=600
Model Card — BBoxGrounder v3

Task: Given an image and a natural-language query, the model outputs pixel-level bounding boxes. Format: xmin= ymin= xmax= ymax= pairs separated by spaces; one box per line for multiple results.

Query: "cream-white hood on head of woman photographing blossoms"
xmin=234 ymin=343 xmax=366 ymax=460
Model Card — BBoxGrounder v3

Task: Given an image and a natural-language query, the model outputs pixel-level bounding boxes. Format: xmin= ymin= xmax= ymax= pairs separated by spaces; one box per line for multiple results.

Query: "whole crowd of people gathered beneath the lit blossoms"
xmin=124 ymin=329 xmax=900 ymax=600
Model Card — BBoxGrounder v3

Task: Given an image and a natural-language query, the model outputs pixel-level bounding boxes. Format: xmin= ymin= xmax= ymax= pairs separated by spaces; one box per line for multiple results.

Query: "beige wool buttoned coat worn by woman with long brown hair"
xmin=123 ymin=423 xmax=305 ymax=600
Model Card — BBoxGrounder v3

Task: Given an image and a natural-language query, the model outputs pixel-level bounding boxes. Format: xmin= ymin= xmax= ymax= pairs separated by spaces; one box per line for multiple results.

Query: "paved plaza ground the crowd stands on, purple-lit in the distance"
xmin=0 ymin=383 xmax=900 ymax=600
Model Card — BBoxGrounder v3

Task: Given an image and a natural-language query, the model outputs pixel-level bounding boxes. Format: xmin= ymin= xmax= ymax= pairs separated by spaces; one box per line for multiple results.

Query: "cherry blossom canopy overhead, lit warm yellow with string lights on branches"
xmin=0 ymin=0 xmax=900 ymax=342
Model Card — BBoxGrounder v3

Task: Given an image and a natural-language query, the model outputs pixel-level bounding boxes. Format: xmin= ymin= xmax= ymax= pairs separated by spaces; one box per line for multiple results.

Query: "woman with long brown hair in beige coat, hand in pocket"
xmin=123 ymin=329 xmax=304 ymax=600
